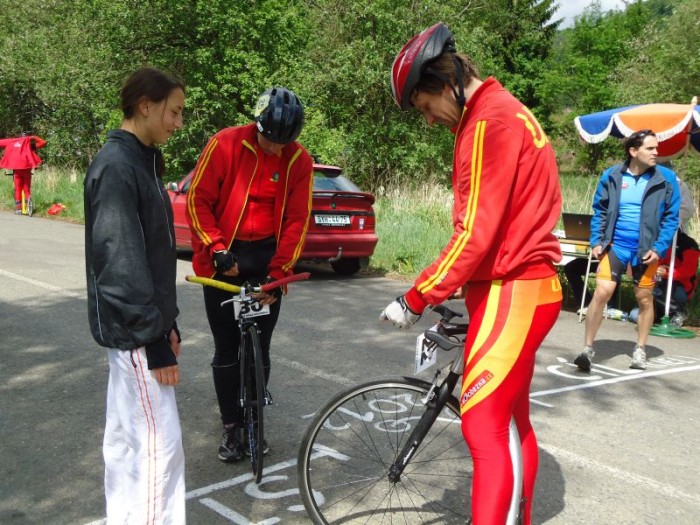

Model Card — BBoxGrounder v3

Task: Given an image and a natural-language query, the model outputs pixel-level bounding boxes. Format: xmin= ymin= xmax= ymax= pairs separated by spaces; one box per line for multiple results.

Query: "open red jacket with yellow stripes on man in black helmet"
xmin=187 ymin=124 xmax=313 ymax=279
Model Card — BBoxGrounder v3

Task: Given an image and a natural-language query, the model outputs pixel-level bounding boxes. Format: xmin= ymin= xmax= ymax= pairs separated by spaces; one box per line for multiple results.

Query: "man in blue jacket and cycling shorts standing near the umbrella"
xmin=574 ymin=130 xmax=681 ymax=372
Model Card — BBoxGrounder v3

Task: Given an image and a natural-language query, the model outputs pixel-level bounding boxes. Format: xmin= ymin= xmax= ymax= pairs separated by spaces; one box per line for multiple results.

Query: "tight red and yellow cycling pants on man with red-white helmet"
xmin=460 ymin=275 xmax=562 ymax=525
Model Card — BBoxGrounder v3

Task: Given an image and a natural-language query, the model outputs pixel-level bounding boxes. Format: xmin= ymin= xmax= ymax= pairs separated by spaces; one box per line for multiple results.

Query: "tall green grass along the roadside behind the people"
xmin=0 ymin=167 xmax=700 ymax=326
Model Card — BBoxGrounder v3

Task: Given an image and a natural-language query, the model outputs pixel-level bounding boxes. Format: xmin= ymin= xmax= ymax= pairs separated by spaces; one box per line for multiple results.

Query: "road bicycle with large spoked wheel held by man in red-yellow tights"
xmin=297 ymin=306 xmax=523 ymax=525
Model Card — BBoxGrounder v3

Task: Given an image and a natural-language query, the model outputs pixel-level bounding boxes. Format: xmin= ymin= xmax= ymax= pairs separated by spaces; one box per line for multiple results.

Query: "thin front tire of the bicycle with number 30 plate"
xmin=241 ymin=325 xmax=265 ymax=483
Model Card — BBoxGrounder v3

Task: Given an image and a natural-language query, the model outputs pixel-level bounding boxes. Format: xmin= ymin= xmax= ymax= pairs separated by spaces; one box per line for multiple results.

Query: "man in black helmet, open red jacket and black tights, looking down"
xmin=187 ymin=87 xmax=313 ymax=462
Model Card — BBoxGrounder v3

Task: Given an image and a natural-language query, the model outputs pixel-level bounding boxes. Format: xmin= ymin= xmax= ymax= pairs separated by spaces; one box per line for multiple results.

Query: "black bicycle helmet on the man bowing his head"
xmin=255 ymin=87 xmax=304 ymax=144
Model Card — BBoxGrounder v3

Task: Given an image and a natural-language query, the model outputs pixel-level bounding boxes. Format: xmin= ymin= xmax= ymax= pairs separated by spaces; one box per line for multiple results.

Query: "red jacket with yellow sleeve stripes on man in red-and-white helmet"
xmin=406 ymin=77 xmax=561 ymax=312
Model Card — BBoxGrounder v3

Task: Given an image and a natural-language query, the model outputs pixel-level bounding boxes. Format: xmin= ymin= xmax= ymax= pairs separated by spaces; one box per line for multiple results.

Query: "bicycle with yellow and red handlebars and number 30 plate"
xmin=185 ymin=272 xmax=311 ymax=483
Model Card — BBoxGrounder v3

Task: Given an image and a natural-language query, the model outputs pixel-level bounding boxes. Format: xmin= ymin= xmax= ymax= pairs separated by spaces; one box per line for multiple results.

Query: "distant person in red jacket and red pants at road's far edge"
xmin=0 ymin=133 xmax=46 ymax=215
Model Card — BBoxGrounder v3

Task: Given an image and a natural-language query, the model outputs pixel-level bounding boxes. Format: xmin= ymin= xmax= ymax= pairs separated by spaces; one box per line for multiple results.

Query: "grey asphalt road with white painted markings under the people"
xmin=0 ymin=212 xmax=700 ymax=525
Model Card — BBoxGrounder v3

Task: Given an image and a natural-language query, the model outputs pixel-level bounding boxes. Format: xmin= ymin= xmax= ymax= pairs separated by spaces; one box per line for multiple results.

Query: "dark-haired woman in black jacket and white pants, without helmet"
xmin=84 ymin=68 xmax=185 ymax=524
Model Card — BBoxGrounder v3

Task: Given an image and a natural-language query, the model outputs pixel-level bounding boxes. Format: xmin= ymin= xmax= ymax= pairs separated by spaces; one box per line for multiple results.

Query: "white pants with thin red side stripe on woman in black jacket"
xmin=103 ymin=348 xmax=185 ymax=525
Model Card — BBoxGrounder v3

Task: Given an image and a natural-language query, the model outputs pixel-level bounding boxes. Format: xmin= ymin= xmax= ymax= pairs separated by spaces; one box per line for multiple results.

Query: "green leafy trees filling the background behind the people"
xmin=0 ymin=0 xmax=700 ymax=189
